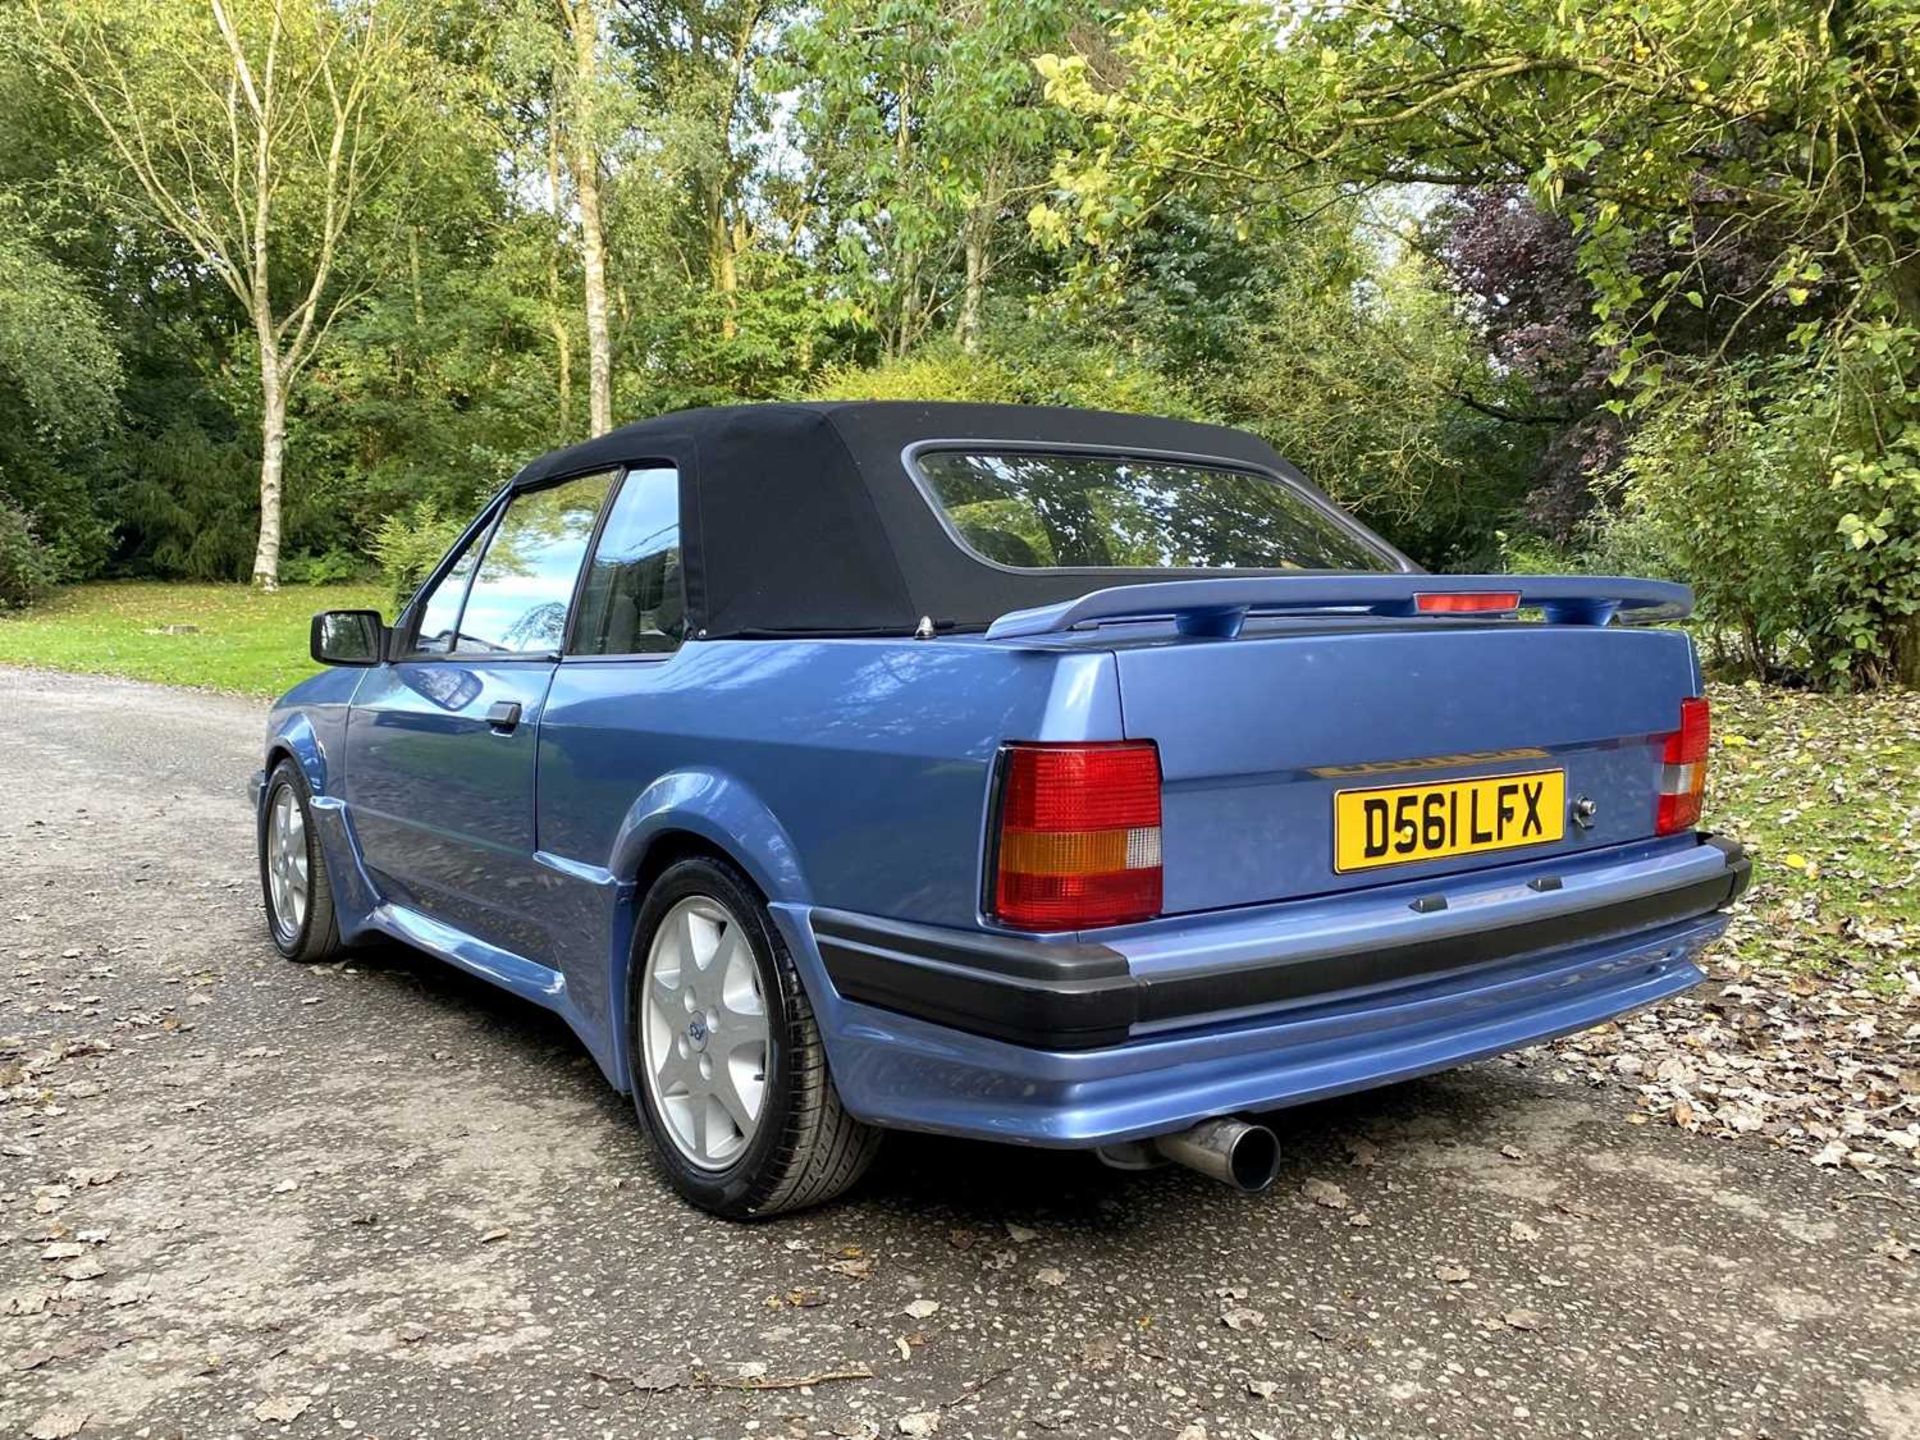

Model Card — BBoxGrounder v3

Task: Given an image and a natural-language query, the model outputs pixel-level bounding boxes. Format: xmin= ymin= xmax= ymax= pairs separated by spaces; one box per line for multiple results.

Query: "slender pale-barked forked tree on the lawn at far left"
xmin=27 ymin=0 xmax=435 ymax=589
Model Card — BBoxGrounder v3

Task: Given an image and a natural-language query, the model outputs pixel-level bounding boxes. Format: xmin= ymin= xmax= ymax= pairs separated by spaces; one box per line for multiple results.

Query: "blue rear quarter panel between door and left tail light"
xmin=536 ymin=639 xmax=1121 ymax=1010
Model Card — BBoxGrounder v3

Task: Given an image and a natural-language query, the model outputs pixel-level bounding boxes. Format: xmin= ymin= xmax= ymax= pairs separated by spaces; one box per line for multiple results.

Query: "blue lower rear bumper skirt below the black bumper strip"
xmin=776 ymin=906 xmax=1726 ymax=1148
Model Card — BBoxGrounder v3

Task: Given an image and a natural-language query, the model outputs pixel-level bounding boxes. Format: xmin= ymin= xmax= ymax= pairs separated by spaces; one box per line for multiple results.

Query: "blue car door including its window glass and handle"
xmin=346 ymin=474 xmax=612 ymax=956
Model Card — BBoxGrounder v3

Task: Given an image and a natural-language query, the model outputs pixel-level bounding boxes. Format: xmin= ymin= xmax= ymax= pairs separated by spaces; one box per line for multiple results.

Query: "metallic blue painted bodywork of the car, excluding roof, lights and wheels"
xmin=267 ymin=602 xmax=1722 ymax=1144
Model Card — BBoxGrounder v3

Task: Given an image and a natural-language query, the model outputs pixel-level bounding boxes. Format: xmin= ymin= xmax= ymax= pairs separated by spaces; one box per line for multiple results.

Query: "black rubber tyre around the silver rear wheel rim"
xmin=626 ymin=856 xmax=881 ymax=1219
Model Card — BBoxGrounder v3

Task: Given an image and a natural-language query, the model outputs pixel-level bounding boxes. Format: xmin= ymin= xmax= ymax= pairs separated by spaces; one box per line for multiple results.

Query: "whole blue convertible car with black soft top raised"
xmin=255 ymin=403 xmax=1747 ymax=1215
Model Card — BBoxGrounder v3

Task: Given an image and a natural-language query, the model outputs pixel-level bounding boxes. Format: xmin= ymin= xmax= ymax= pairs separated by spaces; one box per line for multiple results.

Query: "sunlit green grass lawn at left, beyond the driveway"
xmin=0 ymin=580 xmax=390 ymax=695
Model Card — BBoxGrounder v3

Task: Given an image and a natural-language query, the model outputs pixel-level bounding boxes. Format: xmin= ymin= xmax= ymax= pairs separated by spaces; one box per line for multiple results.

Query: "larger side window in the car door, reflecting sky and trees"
xmin=453 ymin=474 xmax=612 ymax=655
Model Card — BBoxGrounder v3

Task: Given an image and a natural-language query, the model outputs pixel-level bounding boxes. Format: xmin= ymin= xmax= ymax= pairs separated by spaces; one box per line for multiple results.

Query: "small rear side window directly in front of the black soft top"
xmin=574 ymin=465 xmax=685 ymax=655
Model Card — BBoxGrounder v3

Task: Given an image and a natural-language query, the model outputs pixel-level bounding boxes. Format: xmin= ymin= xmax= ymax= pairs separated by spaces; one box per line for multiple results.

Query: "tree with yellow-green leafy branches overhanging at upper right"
xmin=1043 ymin=0 xmax=1920 ymax=678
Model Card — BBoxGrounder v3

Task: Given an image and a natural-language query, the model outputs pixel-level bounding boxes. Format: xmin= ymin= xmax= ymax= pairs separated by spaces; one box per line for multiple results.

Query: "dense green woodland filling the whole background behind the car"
xmin=0 ymin=0 xmax=1920 ymax=687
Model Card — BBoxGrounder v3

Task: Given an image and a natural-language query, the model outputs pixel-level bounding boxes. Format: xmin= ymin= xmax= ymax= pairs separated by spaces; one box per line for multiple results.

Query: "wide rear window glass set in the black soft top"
xmin=916 ymin=449 xmax=1400 ymax=572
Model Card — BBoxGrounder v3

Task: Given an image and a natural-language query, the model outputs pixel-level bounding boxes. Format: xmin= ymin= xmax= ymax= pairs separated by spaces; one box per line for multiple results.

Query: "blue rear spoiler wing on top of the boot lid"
xmin=987 ymin=574 xmax=1693 ymax=639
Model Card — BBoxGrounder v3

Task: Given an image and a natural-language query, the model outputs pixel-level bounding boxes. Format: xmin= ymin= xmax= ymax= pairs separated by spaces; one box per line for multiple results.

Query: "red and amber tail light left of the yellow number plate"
xmin=993 ymin=741 xmax=1160 ymax=929
